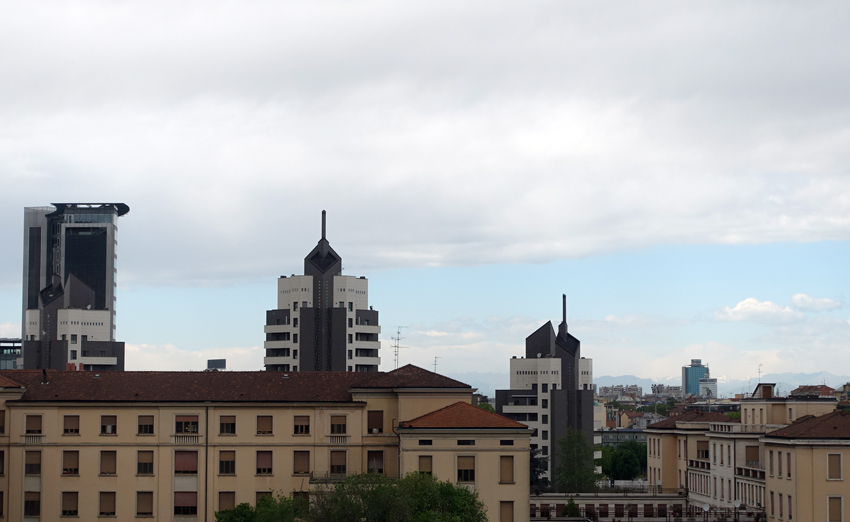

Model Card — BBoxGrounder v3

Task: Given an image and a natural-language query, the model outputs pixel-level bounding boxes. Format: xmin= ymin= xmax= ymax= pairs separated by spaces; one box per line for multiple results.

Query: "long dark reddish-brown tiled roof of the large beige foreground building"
xmin=0 ymin=366 xmax=469 ymax=402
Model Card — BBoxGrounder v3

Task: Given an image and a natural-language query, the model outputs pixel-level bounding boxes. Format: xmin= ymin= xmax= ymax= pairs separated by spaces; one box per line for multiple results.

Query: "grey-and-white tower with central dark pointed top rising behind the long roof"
xmin=263 ymin=210 xmax=381 ymax=372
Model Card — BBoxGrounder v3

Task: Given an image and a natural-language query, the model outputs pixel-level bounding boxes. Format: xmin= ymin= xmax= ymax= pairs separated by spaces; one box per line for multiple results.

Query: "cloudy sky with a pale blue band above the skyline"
xmin=0 ymin=0 xmax=850 ymax=386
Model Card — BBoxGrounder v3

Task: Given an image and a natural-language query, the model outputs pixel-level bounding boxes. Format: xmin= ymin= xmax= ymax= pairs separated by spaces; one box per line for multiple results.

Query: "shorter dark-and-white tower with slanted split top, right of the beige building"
xmin=496 ymin=296 xmax=593 ymax=478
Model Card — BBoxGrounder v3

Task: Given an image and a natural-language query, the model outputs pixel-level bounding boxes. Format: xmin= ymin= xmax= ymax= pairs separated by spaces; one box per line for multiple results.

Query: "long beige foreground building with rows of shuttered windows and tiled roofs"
xmin=0 ymin=365 xmax=531 ymax=522
